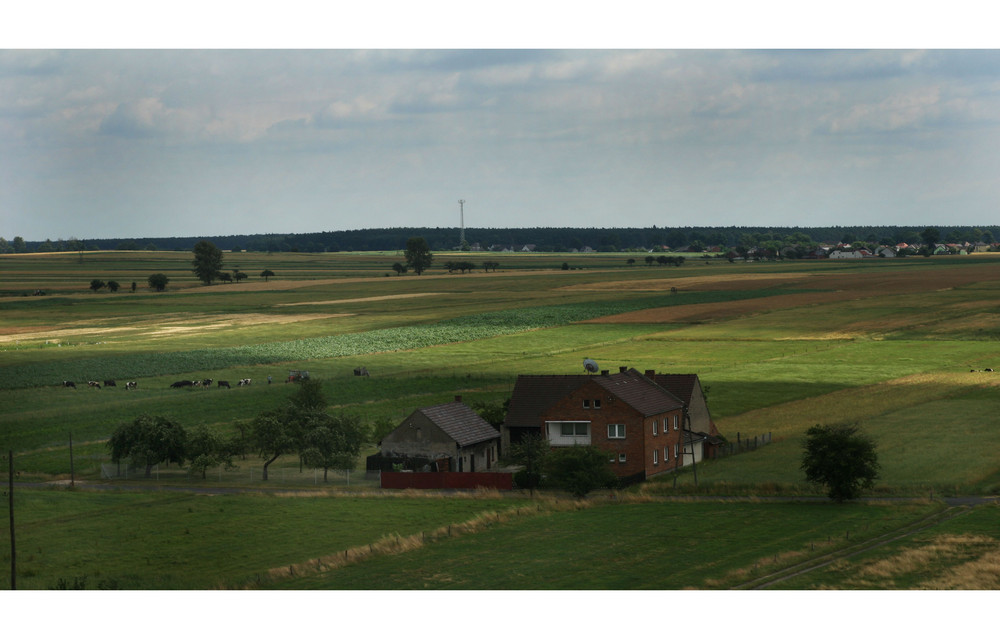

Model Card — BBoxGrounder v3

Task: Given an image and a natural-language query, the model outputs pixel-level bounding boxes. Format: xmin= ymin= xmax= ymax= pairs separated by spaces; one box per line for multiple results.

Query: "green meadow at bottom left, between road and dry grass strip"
xmin=0 ymin=490 xmax=528 ymax=590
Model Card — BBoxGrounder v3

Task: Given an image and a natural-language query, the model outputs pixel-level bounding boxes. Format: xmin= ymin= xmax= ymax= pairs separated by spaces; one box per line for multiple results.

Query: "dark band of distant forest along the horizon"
xmin=7 ymin=226 xmax=1000 ymax=253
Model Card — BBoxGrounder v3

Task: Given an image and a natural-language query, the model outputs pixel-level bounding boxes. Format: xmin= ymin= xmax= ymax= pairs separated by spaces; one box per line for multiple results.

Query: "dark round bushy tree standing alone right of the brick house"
xmin=801 ymin=424 xmax=880 ymax=502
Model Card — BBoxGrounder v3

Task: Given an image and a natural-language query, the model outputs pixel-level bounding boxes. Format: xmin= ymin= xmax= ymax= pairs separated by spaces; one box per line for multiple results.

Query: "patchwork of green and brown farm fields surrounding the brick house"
xmin=0 ymin=252 xmax=1000 ymax=590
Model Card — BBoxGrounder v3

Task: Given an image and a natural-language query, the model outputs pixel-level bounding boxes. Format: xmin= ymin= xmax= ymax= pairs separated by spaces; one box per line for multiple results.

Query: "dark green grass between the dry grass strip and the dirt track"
xmin=270 ymin=502 xmax=930 ymax=590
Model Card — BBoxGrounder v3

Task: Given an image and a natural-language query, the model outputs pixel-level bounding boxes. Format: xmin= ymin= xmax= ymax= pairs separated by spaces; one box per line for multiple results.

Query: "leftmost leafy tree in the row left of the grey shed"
xmin=107 ymin=415 xmax=187 ymax=477
